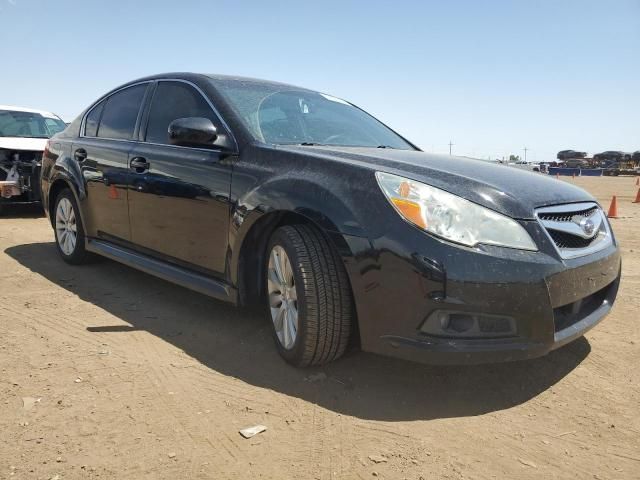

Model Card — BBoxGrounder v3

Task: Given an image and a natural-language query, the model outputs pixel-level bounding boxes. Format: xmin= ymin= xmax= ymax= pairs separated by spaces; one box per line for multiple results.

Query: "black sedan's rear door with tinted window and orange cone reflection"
xmin=72 ymin=83 xmax=150 ymax=242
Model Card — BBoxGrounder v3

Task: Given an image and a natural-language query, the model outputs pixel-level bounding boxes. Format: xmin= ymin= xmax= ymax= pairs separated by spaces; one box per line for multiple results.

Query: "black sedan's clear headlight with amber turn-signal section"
xmin=376 ymin=172 xmax=537 ymax=251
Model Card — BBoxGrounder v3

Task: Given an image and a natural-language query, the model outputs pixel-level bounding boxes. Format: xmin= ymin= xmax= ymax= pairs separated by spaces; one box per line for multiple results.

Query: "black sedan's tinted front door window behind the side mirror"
xmin=146 ymin=82 xmax=215 ymax=144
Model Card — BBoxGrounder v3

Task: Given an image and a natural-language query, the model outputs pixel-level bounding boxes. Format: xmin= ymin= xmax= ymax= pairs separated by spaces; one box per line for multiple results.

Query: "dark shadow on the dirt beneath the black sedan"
xmin=5 ymin=243 xmax=590 ymax=421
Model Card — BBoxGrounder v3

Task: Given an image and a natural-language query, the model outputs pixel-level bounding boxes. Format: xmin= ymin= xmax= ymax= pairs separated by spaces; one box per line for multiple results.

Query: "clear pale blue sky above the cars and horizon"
xmin=0 ymin=0 xmax=640 ymax=161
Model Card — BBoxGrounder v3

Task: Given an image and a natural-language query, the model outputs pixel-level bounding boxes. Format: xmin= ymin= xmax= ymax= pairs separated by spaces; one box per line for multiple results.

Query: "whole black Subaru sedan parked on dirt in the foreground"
xmin=42 ymin=73 xmax=620 ymax=366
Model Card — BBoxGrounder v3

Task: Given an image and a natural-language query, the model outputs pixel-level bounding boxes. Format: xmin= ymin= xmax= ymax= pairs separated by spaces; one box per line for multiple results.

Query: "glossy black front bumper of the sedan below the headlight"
xmin=344 ymin=216 xmax=621 ymax=364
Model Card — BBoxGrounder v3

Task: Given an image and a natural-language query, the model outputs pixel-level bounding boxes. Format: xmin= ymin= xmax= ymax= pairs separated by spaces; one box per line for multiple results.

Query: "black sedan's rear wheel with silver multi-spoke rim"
xmin=52 ymin=188 xmax=91 ymax=265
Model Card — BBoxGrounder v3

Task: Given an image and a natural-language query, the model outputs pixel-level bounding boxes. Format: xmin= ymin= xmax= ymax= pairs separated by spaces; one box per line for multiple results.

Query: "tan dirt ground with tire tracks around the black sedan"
xmin=0 ymin=177 xmax=640 ymax=479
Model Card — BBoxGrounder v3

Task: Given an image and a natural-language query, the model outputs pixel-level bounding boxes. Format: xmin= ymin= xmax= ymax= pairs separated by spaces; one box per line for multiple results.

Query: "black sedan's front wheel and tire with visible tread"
xmin=264 ymin=225 xmax=353 ymax=367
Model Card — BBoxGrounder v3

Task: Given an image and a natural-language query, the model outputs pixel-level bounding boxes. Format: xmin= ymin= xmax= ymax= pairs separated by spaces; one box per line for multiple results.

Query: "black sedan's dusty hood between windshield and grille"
xmin=278 ymin=145 xmax=596 ymax=219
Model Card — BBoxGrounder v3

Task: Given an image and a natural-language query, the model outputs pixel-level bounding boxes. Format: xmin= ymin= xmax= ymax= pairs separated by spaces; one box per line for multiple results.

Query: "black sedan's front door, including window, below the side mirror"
xmin=128 ymin=80 xmax=231 ymax=276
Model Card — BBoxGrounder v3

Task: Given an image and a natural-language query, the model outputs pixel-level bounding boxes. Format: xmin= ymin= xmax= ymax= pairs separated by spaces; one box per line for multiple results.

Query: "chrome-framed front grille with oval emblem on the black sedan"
xmin=536 ymin=203 xmax=611 ymax=258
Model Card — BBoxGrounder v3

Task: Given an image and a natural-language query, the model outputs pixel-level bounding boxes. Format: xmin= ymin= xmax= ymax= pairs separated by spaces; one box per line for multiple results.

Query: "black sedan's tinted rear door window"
xmin=97 ymin=83 xmax=147 ymax=140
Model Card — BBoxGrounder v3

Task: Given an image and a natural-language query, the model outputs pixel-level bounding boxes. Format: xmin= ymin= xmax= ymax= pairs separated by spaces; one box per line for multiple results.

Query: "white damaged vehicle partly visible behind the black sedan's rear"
xmin=0 ymin=105 xmax=66 ymax=212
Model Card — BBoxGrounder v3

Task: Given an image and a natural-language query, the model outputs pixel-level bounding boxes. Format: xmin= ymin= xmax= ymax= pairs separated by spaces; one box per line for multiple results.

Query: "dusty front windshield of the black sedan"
xmin=213 ymin=80 xmax=414 ymax=150
